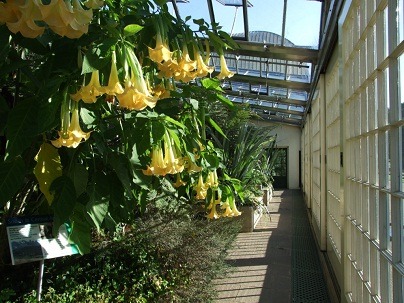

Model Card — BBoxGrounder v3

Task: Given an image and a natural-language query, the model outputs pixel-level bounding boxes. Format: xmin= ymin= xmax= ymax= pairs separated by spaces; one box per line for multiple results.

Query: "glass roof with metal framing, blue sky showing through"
xmin=171 ymin=0 xmax=323 ymax=126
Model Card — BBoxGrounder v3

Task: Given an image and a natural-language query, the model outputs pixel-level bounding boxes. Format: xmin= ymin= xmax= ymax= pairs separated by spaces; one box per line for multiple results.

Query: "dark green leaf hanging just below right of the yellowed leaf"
xmin=50 ymin=176 xmax=77 ymax=233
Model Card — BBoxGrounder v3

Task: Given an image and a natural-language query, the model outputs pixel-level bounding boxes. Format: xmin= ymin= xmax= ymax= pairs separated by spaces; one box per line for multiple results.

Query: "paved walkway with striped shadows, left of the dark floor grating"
xmin=215 ymin=190 xmax=329 ymax=303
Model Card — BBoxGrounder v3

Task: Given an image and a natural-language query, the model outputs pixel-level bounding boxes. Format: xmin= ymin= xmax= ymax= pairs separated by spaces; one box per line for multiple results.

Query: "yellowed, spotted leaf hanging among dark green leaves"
xmin=34 ymin=143 xmax=62 ymax=205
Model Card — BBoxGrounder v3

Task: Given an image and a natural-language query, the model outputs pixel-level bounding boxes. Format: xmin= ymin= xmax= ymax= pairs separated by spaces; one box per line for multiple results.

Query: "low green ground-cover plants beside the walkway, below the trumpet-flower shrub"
xmin=0 ymin=214 xmax=240 ymax=303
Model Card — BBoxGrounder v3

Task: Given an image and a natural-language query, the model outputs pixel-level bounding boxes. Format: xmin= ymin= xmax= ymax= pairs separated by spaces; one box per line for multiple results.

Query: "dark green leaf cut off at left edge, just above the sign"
xmin=0 ymin=157 xmax=25 ymax=207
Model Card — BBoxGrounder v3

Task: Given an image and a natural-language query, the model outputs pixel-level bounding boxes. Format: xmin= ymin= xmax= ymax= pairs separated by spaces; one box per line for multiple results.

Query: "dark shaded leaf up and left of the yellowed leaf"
xmin=6 ymin=98 xmax=38 ymax=158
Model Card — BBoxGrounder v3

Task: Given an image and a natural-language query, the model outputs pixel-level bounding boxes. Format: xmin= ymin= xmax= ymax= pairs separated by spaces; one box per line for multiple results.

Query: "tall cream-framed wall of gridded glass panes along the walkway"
xmin=302 ymin=0 xmax=404 ymax=302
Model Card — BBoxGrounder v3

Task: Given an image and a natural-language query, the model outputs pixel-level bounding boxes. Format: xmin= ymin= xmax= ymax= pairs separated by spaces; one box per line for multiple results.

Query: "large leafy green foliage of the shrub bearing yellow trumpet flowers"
xmin=0 ymin=0 xmax=241 ymax=258
